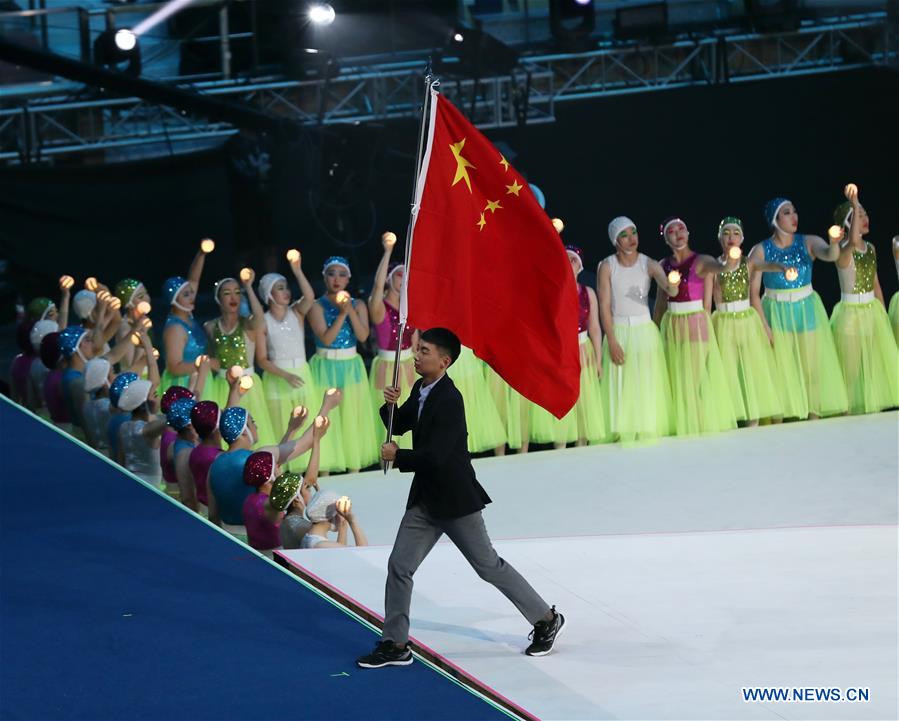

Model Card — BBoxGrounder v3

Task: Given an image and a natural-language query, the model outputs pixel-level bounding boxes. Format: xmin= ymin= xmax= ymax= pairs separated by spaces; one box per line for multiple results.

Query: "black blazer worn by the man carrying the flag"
xmin=381 ymin=375 xmax=490 ymax=519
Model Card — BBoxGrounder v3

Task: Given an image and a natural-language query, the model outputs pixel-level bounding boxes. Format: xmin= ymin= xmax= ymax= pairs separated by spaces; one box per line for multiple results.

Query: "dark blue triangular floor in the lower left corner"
xmin=0 ymin=399 xmax=507 ymax=721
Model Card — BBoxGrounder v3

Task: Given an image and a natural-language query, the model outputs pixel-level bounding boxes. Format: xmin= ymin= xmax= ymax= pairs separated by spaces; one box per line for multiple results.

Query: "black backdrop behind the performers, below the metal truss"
xmin=0 ymin=69 xmax=899 ymax=320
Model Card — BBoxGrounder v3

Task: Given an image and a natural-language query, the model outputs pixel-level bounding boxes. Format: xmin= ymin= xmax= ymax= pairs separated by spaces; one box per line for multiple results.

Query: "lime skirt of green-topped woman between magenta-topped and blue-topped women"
xmin=712 ymin=308 xmax=783 ymax=421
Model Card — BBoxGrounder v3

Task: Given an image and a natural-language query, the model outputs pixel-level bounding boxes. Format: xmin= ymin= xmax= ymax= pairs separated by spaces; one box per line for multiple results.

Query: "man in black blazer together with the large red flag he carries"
xmin=356 ymin=89 xmax=568 ymax=668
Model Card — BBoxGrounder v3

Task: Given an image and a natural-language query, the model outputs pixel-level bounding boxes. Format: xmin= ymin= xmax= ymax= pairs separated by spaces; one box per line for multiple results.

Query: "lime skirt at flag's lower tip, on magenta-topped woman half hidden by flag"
xmin=530 ymin=338 xmax=611 ymax=444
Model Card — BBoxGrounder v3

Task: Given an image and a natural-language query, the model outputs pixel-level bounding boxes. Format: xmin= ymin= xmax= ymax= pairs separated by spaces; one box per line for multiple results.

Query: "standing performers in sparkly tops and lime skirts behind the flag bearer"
xmin=11 ymin=184 xmax=899 ymax=484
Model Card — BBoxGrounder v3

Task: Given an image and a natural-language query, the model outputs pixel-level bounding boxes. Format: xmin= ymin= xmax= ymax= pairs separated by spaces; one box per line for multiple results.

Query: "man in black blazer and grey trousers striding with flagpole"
xmin=356 ymin=328 xmax=565 ymax=668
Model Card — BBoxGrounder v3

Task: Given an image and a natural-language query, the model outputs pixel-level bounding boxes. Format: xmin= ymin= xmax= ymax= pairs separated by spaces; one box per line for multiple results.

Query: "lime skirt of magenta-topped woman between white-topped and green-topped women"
xmin=661 ymin=310 xmax=737 ymax=436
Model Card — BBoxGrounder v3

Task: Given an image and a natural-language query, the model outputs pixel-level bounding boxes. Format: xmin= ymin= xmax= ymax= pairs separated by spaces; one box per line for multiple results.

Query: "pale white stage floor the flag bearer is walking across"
xmin=283 ymin=414 xmax=899 ymax=720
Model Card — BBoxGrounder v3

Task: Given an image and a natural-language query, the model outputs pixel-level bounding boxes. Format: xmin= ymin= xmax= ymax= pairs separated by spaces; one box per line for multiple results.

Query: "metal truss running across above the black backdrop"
xmin=0 ymin=13 xmax=897 ymax=163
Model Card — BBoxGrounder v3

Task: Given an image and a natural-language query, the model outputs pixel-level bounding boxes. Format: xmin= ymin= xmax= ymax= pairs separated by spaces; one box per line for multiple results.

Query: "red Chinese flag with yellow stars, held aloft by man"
xmin=407 ymin=93 xmax=580 ymax=418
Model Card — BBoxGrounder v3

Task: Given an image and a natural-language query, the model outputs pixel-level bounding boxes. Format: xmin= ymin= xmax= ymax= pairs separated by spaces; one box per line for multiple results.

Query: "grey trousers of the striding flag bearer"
xmin=382 ymin=505 xmax=549 ymax=644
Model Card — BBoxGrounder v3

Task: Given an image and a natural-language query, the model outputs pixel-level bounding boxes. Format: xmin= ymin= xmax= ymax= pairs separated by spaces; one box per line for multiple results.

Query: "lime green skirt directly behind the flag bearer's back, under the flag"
xmin=446 ymin=346 xmax=506 ymax=453
